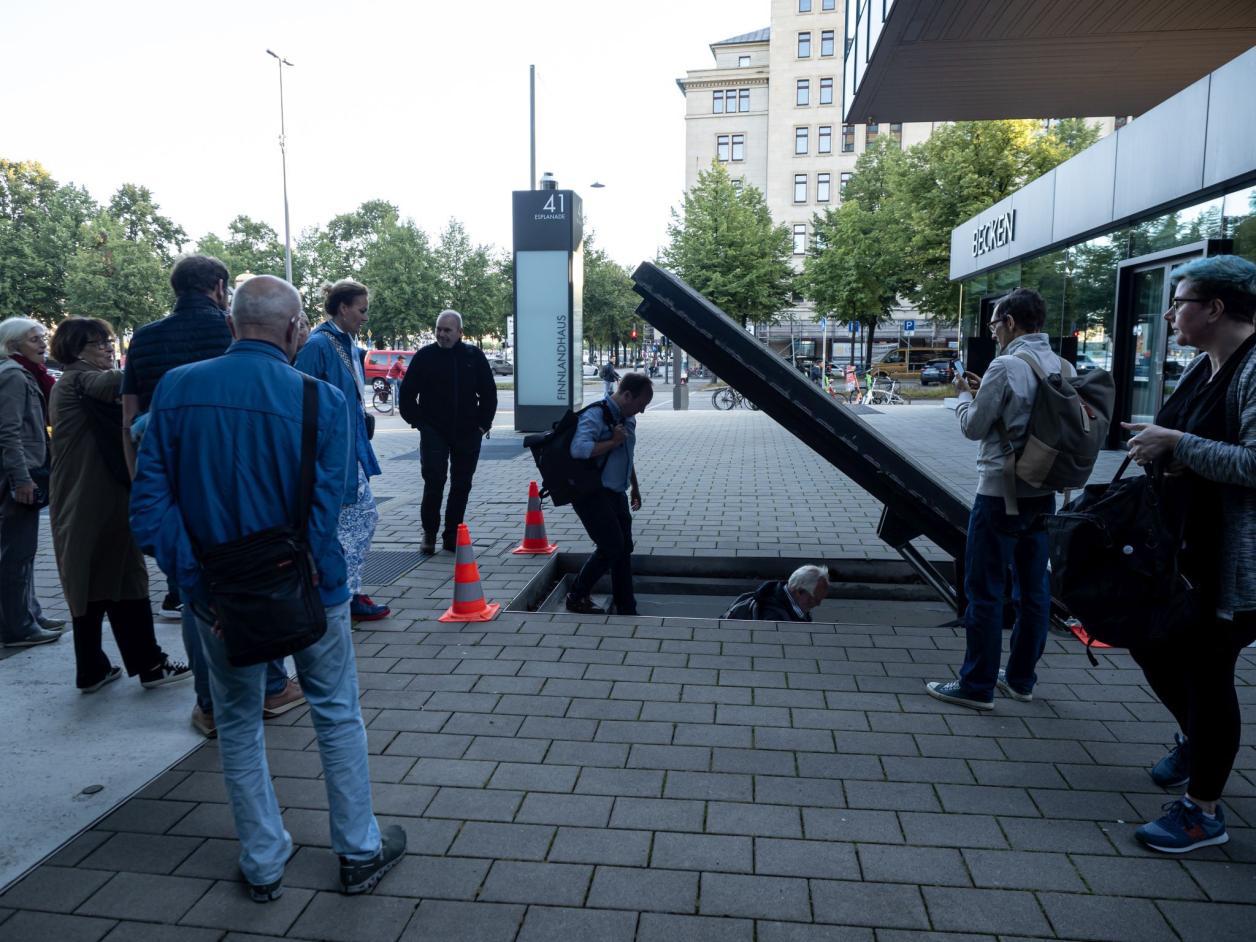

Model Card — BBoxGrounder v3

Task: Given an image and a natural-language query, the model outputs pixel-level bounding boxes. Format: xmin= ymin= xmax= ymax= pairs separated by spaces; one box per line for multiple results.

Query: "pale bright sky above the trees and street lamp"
xmin=0 ymin=0 xmax=770 ymax=265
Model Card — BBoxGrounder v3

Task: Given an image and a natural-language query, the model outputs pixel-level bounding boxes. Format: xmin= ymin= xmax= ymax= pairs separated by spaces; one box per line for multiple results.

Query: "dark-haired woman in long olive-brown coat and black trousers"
xmin=49 ymin=318 xmax=192 ymax=693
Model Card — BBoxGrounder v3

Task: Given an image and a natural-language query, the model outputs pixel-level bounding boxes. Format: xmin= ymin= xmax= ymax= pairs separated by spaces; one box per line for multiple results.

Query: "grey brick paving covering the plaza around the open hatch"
xmin=0 ymin=407 xmax=1256 ymax=942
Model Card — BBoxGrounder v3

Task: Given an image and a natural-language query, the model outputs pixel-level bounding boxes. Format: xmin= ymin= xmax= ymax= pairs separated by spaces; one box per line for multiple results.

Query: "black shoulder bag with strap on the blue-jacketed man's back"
xmin=198 ymin=376 xmax=327 ymax=667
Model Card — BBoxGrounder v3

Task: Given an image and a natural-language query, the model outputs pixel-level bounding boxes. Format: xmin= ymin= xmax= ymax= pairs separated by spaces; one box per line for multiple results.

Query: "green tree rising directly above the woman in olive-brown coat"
xmin=65 ymin=211 xmax=170 ymax=335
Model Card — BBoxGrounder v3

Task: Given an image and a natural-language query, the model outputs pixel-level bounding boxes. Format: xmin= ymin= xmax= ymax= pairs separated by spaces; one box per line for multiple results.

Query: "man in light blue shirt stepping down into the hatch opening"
xmin=566 ymin=373 xmax=654 ymax=615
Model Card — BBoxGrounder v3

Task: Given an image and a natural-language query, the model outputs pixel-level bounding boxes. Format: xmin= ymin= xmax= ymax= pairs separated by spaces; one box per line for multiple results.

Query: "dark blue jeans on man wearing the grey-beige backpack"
xmin=960 ymin=494 xmax=1055 ymax=701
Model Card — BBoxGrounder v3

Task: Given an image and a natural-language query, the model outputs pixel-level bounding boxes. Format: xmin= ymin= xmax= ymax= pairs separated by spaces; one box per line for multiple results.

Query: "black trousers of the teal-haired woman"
xmin=1129 ymin=612 xmax=1256 ymax=801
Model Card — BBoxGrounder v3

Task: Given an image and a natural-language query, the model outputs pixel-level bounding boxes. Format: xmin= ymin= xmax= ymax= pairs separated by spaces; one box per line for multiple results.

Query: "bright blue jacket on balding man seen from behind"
xmin=131 ymin=340 xmax=352 ymax=605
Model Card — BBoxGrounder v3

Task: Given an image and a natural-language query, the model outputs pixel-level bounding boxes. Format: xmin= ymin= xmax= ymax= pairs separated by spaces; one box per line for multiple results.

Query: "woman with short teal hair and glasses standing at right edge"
xmin=1125 ymin=255 xmax=1256 ymax=854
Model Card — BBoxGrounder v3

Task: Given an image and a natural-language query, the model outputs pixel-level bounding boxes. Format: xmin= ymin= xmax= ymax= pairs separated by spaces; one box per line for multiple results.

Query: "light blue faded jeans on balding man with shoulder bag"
xmin=193 ymin=602 xmax=379 ymax=884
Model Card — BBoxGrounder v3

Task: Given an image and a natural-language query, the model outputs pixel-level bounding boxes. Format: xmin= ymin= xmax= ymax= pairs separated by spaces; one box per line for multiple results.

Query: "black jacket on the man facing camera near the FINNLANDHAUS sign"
xmin=398 ymin=340 xmax=497 ymax=441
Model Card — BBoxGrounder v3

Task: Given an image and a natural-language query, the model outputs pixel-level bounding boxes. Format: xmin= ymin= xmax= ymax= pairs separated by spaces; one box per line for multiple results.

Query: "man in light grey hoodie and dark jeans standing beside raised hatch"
xmin=926 ymin=288 xmax=1075 ymax=710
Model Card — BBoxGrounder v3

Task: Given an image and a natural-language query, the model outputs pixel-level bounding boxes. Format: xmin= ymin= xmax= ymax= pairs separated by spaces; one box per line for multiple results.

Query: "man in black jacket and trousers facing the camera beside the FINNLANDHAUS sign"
xmin=399 ymin=310 xmax=497 ymax=554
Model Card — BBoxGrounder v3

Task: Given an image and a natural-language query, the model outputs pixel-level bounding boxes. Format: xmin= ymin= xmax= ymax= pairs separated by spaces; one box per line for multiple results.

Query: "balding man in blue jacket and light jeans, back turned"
xmin=131 ymin=275 xmax=406 ymax=902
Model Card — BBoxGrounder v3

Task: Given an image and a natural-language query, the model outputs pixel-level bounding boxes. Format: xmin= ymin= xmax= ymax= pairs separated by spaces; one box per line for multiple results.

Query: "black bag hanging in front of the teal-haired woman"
xmin=1045 ymin=457 xmax=1202 ymax=666
